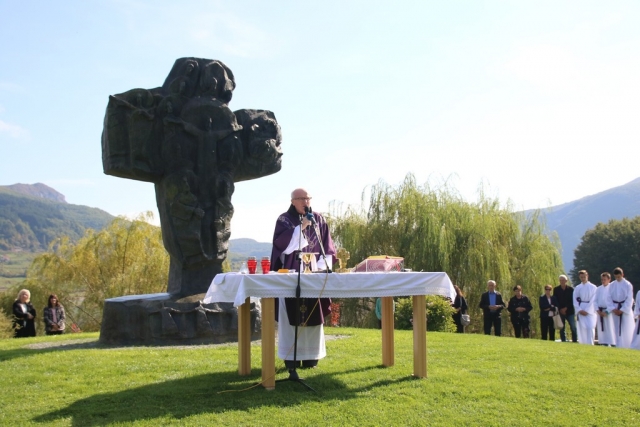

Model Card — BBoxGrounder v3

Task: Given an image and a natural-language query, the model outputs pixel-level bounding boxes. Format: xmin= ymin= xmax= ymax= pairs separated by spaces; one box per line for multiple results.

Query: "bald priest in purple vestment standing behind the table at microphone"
xmin=271 ymin=188 xmax=336 ymax=370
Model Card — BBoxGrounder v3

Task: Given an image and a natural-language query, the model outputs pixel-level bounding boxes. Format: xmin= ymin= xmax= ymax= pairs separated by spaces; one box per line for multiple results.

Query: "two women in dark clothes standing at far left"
xmin=13 ymin=289 xmax=65 ymax=338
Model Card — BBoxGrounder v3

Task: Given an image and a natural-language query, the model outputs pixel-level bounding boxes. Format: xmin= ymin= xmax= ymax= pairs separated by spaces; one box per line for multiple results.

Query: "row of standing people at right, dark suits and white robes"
xmin=460 ymin=267 xmax=640 ymax=349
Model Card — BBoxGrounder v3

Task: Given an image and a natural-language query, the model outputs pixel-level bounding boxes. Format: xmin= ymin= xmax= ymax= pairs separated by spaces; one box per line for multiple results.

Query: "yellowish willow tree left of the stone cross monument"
xmin=14 ymin=213 xmax=169 ymax=331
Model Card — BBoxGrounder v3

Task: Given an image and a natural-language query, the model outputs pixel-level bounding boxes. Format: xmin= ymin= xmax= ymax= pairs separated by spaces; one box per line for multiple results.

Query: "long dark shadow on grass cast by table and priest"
xmin=32 ymin=365 xmax=412 ymax=426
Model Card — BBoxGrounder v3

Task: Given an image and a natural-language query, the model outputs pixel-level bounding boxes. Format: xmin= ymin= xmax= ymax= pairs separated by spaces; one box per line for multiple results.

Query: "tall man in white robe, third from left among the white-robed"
xmin=607 ymin=267 xmax=635 ymax=348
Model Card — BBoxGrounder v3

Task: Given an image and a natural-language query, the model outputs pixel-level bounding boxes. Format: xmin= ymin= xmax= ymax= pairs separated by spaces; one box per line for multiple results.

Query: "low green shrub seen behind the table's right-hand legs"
xmin=395 ymin=295 xmax=455 ymax=332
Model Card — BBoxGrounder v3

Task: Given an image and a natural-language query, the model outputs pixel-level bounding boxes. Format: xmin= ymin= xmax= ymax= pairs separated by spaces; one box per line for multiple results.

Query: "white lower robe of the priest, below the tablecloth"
xmin=278 ymin=298 xmax=327 ymax=360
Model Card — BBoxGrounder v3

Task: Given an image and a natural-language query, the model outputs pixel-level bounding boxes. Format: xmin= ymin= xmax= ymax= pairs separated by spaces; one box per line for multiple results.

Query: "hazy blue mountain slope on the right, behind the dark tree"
xmin=543 ymin=178 xmax=640 ymax=272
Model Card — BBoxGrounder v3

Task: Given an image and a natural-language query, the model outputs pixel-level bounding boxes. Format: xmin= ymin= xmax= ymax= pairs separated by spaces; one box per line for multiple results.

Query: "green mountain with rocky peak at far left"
xmin=0 ymin=184 xmax=114 ymax=252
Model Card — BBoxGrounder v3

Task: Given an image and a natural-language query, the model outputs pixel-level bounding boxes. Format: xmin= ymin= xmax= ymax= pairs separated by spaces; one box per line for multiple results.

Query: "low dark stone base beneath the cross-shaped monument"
xmin=100 ymin=293 xmax=262 ymax=345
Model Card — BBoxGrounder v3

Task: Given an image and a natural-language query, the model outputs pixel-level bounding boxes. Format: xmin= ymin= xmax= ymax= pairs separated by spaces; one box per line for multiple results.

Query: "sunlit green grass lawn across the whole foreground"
xmin=0 ymin=328 xmax=640 ymax=426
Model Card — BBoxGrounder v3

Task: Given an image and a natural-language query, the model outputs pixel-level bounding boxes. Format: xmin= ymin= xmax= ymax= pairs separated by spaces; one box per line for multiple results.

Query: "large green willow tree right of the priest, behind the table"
xmin=328 ymin=174 xmax=562 ymax=331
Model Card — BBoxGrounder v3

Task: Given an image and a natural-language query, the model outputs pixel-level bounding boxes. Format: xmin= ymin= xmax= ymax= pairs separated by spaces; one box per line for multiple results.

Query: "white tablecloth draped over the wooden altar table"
xmin=204 ymin=272 xmax=456 ymax=307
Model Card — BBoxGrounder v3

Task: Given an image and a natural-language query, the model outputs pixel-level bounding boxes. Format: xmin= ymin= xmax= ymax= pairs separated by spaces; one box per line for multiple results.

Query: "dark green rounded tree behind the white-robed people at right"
xmin=571 ymin=216 xmax=640 ymax=296
